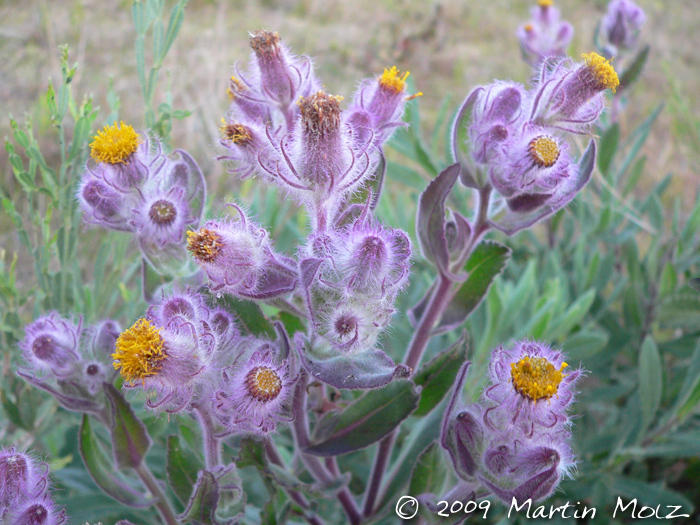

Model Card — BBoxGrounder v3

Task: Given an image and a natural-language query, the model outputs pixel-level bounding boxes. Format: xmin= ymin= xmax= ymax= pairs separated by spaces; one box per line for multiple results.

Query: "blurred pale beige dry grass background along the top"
xmin=0 ymin=0 xmax=700 ymax=248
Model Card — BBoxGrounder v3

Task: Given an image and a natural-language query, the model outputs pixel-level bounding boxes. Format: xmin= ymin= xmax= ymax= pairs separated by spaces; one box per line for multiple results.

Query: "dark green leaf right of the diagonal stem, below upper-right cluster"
xmin=435 ymin=241 xmax=510 ymax=333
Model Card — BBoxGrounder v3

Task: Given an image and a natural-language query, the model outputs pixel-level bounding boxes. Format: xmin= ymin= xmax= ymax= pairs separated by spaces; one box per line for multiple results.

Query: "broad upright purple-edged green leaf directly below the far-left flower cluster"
xmin=104 ymin=383 xmax=151 ymax=469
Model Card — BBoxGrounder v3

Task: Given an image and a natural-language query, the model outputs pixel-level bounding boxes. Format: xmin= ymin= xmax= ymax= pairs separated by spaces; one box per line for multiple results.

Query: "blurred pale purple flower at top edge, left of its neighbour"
xmin=518 ymin=0 xmax=574 ymax=67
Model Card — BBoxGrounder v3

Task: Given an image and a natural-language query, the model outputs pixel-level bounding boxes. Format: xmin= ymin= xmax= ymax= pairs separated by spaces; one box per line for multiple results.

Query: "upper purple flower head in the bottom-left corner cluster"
xmin=0 ymin=447 xmax=49 ymax=518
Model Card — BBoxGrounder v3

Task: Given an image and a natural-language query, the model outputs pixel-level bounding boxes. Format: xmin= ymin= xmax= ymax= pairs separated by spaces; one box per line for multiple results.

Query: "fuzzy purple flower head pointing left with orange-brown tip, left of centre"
xmin=187 ymin=204 xmax=298 ymax=299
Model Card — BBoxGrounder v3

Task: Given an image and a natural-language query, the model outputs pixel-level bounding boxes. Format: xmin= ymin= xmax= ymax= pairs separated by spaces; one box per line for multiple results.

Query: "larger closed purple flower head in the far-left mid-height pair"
xmin=20 ymin=312 xmax=82 ymax=378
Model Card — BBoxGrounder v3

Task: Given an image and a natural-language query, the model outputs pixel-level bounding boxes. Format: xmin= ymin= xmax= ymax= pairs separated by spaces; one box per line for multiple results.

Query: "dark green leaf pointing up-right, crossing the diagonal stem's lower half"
xmin=413 ymin=331 xmax=468 ymax=416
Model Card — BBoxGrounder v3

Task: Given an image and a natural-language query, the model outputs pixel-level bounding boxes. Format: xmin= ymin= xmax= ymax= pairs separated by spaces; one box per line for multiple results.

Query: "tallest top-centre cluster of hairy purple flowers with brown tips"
xmin=219 ymin=31 xmax=416 ymax=229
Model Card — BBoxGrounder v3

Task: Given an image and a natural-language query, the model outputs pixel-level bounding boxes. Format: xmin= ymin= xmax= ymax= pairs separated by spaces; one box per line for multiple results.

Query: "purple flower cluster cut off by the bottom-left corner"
xmin=0 ymin=448 xmax=66 ymax=525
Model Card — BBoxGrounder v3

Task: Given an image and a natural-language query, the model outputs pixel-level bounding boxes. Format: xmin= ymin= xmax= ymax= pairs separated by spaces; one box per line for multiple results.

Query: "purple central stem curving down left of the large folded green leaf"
xmin=292 ymin=371 xmax=362 ymax=525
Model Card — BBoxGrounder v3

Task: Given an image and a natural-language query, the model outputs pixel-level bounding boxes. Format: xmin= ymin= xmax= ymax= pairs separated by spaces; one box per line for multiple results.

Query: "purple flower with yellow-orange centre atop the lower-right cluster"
xmin=482 ymin=341 xmax=583 ymax=434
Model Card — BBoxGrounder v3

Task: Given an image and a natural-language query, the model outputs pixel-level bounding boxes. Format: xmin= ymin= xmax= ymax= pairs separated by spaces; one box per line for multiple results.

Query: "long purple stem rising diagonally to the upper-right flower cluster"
xmin=363 ymin=185 xmax=491 ymax=517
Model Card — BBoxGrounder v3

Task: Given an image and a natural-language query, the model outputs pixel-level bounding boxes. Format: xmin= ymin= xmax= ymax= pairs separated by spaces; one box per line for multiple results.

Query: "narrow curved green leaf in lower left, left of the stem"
xmin=79 ymin=414 xmax=155 ymax=508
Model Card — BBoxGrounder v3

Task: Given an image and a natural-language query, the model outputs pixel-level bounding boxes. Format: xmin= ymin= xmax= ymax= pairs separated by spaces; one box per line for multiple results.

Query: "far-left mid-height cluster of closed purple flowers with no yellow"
xmin=18 ymin=312 xmax=121 ymax=413
